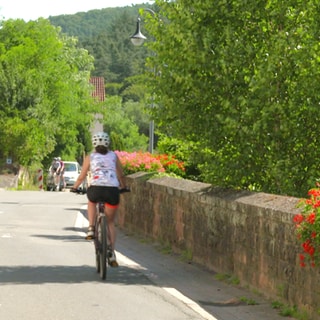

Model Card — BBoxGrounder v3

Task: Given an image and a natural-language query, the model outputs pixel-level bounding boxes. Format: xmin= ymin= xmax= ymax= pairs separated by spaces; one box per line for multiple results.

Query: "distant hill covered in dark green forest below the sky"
xmin=49 ymin=4 xmax=150 ymax=84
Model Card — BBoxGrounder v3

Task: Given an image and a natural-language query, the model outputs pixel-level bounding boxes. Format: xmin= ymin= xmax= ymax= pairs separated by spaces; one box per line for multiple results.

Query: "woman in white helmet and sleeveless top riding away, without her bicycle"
xmin=71 ymin=132 xmax=126 ymax=267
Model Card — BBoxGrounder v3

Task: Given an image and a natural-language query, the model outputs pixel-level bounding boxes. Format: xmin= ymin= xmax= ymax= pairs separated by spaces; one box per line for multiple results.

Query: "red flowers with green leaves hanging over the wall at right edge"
xmin=293 ymin=185 xmax=320 ymax=267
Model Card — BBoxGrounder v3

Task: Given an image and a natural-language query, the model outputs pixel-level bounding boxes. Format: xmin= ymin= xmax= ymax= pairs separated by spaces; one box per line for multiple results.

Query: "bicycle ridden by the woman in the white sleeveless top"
xmin=71 ymin=188 xmax=130 ymax=280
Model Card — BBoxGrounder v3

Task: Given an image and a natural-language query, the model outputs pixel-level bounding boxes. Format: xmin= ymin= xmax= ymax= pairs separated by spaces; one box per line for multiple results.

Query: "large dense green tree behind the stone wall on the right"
xmin=143 ymin=0 xmax=320 ymax=196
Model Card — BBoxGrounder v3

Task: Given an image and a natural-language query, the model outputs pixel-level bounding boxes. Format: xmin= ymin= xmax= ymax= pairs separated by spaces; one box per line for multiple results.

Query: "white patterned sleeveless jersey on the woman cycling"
xmin=90 ymin=151 xmax=120 ymax=187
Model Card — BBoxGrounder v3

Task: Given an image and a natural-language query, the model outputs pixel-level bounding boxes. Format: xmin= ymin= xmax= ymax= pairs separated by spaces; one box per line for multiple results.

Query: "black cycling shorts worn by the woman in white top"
xmin=87 ymin=186 xmax=120 ymax=206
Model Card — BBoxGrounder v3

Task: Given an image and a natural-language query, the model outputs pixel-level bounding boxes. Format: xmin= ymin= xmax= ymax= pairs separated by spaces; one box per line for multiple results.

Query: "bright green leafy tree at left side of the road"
xmin=0 ymin=19 xmax=96 ymax=166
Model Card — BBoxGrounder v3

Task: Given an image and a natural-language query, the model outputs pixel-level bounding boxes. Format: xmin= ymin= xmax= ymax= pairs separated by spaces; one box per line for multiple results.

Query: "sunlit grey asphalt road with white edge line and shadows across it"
xmin=0 ymin=190 xmax=288 ymax=320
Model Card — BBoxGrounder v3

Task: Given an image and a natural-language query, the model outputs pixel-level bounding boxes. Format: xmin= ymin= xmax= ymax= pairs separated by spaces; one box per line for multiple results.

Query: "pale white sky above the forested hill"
xmin=0 ymin=0 xmax=152 ymax=21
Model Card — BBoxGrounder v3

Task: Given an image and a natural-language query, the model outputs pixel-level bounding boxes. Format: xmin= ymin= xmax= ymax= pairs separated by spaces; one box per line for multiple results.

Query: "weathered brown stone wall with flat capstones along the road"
xmin=119 ymin=173 xmax=320 ymax=319
